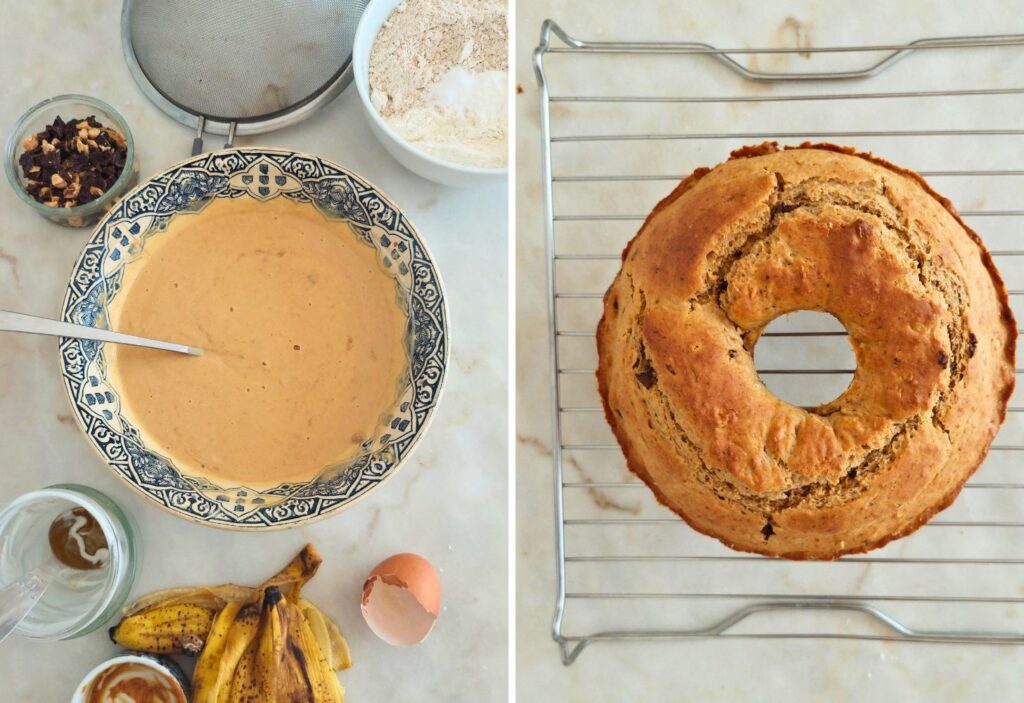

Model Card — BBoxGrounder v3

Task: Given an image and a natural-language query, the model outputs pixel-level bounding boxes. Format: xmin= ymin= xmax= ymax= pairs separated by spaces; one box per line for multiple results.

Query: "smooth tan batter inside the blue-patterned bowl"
xmin=106 ymin=197 xmax=409 ymax=488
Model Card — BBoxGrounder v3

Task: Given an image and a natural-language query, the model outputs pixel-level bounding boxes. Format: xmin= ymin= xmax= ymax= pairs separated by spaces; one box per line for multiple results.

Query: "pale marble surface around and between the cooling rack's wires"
xmin=516 ymin=0 xmax=1024 ymax=702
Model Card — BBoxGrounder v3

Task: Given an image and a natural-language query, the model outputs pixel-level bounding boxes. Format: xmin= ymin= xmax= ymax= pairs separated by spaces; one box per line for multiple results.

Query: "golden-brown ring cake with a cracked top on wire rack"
xmin=597 ymin=142 xmax=1017 ymax=559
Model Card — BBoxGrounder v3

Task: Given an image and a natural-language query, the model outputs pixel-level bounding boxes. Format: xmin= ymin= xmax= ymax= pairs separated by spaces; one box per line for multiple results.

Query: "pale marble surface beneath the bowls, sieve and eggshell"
xmin=0 ymin=0 xmax=508 ymax=703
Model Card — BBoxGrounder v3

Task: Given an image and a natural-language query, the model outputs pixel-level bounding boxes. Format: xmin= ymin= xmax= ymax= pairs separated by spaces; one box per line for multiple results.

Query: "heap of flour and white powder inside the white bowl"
xmin=370 ymin=0 xmax=508 ymax=168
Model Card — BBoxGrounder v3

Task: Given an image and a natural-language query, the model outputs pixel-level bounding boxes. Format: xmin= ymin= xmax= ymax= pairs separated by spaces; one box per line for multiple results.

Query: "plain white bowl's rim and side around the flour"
xmin=352 ymin=0 xmax=508 ymax=185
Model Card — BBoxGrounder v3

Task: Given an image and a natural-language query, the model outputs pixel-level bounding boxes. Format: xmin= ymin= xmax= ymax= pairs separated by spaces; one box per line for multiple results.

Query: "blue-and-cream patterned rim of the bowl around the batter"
xmin=60 ymin=148 xmax=449 ymax=530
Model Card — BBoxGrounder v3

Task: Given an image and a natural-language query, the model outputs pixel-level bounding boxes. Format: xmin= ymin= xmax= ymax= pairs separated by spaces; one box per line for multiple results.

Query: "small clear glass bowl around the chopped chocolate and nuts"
xmin=4 ymin=95 xmax=138 ymax=227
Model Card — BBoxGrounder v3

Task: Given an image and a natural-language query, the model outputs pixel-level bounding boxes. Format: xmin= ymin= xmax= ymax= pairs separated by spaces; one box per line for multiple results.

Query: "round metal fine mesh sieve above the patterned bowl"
xmin=121 ymin=0 xmax=367 ymax=153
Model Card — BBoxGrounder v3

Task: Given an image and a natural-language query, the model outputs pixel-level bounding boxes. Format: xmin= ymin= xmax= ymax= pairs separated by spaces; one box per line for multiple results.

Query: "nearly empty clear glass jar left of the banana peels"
xmin=0 ymin=484 xmax=139 ymax=640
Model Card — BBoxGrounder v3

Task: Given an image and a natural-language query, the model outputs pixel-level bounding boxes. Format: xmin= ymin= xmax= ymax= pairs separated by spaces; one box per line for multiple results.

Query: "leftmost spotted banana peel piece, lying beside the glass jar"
xmin=110 ymin=604 xmax=214 ymax=654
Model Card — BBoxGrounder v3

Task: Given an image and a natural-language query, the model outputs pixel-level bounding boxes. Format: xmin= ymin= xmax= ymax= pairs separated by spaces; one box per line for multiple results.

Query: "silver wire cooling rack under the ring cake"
xmin=535 ymin=20 xmax=1024 ymax=664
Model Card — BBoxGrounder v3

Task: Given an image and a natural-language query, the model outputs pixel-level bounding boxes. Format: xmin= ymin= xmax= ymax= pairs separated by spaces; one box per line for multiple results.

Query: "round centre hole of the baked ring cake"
xmin=755 ymin=310 xmax=857 ymax=407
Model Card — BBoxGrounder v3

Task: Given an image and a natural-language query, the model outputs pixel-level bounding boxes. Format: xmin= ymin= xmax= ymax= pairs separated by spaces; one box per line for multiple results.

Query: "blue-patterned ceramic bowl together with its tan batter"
xmin=60 ymin=148 xmax=449 ymax=530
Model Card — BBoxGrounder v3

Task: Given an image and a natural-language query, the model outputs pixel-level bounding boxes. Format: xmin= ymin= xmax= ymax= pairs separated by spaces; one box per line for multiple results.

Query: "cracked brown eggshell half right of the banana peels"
xmin=361 ymin=554 xmax=441 ymax=647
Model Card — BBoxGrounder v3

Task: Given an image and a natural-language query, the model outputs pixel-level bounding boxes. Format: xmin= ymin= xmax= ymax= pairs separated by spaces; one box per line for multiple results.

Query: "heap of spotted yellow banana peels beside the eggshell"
xmin=111 ymin=544 xmax=351 ymax=703
